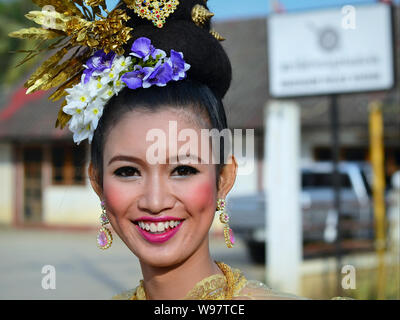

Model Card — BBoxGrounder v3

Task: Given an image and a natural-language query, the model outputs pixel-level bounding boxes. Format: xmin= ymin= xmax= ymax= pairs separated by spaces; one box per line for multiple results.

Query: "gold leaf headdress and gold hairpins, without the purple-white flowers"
xmin=9 ymin=0 xmax=223 ymax=128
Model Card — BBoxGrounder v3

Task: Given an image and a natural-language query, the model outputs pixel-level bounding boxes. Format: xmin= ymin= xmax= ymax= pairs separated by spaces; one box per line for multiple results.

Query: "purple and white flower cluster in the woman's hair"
xmin=63 ymin=37 xmax=190 ymax=144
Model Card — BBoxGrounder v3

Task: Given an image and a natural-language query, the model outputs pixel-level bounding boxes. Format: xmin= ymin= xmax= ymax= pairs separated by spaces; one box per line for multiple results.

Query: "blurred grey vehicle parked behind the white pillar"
xmin=227 ymin=162 xmax=374 ymax=262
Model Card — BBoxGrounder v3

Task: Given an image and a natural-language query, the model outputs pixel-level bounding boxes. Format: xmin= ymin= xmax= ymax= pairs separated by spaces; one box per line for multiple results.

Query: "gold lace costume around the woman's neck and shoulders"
xmin=113 ymin=262 xmax=307 ymax=300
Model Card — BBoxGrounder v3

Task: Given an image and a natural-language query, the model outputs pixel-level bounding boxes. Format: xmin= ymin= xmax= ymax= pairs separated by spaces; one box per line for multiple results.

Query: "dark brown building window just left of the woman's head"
xmin=51 ymin=145 xmax=86 ymax=185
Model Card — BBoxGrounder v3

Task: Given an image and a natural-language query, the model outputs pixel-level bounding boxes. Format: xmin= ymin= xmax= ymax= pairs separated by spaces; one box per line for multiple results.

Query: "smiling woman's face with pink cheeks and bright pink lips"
xmin=103 ymin=109 xmax=217 ymax=267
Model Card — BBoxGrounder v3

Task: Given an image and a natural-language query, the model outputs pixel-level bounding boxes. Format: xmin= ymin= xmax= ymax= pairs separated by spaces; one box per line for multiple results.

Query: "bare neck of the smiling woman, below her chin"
xmin=140 ymin=237 xmax=223 ymax=300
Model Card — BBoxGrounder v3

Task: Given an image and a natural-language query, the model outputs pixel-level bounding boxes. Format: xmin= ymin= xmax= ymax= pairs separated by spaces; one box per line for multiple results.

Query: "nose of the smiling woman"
xmin=138 ymin=172 xmax=175 ymax=214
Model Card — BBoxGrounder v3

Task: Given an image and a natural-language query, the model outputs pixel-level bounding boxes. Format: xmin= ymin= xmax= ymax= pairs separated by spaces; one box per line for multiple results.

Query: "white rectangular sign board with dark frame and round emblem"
xmin=268 ymin=3 xmax=394 ymax=97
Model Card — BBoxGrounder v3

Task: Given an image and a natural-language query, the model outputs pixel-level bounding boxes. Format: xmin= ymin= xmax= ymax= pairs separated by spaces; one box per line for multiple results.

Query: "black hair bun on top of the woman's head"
xmin=121 ymin=0 xmax=232 ymax=99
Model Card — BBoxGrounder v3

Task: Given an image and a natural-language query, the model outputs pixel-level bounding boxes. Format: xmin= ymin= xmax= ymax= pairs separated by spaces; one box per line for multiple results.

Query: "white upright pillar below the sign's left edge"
xmin=264 ymin=101 xmax=303 ymax=294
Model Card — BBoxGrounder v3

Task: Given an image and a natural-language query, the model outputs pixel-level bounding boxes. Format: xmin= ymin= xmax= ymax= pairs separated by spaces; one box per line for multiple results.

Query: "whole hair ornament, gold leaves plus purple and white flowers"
xmin=9 ymin=0 xmax=224 ymax=144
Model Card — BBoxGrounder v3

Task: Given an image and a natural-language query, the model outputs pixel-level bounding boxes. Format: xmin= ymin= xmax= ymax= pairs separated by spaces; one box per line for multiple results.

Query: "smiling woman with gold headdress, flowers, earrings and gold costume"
xmin=9 ymin=0 xmax=312 ymax=299
